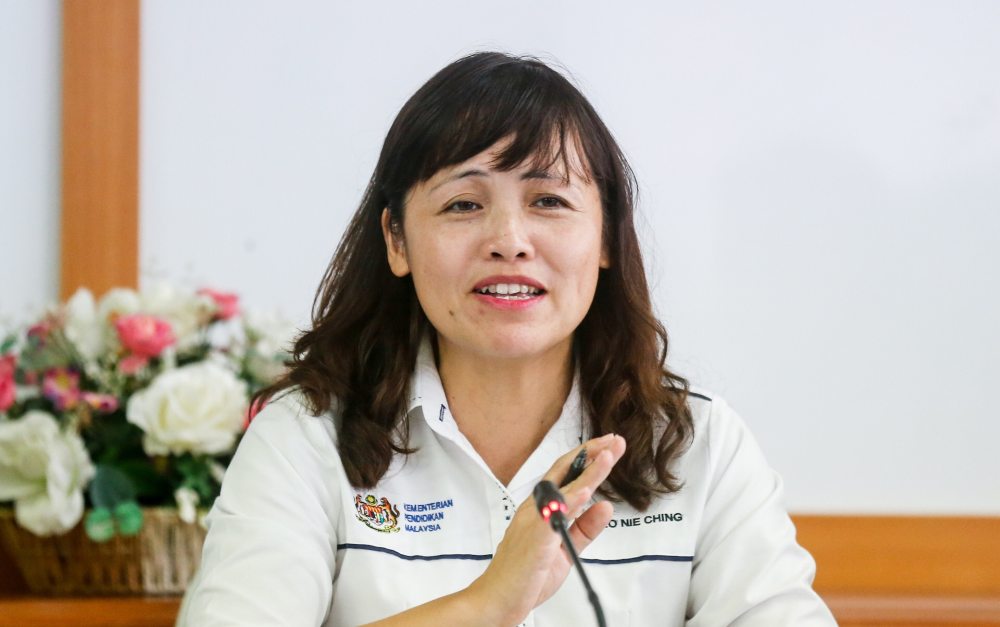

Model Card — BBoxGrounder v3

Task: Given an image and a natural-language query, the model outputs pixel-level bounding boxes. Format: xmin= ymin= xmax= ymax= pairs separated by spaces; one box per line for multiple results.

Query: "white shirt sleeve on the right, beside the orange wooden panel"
xmin=687 ymin=399 xmax=837 ymax=627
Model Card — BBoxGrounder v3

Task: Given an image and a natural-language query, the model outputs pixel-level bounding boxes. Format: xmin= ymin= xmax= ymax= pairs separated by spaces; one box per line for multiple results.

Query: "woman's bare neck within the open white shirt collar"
xmin=438 ymin=339 xmax=573 ymax=485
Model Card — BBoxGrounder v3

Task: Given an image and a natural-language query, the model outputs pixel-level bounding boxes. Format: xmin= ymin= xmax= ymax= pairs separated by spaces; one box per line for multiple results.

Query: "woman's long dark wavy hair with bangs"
xmin=254 ymin=52 xmax=693 ymax=510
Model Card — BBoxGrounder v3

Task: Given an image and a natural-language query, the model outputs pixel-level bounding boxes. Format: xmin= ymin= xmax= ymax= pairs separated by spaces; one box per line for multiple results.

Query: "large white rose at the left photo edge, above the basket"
xmin=0 ymin=411 xmax=94 ymax=536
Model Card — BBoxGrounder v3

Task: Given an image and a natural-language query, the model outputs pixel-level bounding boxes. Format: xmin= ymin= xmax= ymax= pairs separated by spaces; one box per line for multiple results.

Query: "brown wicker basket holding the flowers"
xmin=0 ymin=507 xmax=205 ymax=595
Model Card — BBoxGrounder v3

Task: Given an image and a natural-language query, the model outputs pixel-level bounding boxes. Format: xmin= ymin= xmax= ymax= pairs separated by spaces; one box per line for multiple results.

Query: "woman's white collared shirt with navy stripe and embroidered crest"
xmin=178 ymin=344 xmax=836 ymax=627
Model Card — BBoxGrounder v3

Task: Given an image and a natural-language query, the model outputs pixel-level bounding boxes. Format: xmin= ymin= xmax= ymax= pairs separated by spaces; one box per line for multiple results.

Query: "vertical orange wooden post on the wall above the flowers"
xmin=59 ymin=0 xmax=139 ymax=298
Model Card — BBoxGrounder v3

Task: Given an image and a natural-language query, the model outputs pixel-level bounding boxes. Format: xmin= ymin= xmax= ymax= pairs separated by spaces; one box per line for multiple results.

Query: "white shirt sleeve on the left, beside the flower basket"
xmin=177 ymin=397 xmax=340 ymax=627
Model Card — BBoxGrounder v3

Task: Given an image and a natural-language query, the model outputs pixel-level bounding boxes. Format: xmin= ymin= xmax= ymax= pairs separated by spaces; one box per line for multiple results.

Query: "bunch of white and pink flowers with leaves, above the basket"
xmin=0 ymin=284 xmax=294 ymax=542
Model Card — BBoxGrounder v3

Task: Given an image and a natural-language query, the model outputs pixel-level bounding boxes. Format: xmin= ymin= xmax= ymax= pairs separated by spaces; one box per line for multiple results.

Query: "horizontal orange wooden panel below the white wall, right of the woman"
xmin=793 ymin=516 xmax=1000 ymax=597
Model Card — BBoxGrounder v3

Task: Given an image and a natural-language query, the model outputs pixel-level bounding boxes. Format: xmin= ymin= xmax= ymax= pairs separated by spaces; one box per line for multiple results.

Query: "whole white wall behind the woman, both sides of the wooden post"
xmin=0 ymin=0 xmax=1000 ymax=515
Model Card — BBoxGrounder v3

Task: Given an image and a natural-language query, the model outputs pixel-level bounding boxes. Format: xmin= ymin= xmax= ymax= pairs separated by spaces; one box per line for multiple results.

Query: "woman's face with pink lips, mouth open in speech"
xmin=382 ymin=139 xmax=608 ymax=366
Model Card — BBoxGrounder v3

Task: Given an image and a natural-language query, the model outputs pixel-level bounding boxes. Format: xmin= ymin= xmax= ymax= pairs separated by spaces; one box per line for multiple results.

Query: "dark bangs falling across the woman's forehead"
xmin=396 ymin=56 xmax=606 ymax=194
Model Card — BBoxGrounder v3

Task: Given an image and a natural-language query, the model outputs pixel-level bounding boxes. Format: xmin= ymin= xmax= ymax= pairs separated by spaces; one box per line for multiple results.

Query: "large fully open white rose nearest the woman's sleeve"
xmin=126 ymin=361 xmax=248 ymax=455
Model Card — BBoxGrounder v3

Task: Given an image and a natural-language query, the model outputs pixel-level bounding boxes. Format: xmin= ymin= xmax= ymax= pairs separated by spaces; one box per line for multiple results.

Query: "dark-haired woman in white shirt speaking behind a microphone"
xmin=180 ymin=53 xmax=834 ymax=627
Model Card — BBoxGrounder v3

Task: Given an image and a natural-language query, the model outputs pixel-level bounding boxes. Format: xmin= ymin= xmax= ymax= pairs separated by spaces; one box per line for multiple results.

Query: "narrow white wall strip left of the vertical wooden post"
xmin=0 ymin=0 xmax=62 ymax=324
